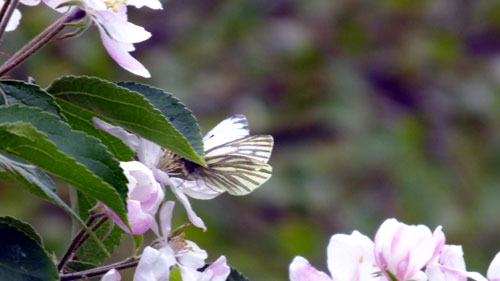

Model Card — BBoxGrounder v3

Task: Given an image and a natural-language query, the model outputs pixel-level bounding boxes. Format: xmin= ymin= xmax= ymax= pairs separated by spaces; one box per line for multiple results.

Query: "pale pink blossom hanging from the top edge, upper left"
xmin=43 ymin=0 xmax=162 ymax=78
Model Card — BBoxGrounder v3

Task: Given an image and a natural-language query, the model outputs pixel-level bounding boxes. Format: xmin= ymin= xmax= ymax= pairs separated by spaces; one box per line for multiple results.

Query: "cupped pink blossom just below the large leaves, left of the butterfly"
xmin=106 ymin=161 xmax=164 ymax=235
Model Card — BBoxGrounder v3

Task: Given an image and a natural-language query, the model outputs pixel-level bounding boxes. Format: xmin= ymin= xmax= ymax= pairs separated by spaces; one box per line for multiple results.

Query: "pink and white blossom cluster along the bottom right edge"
xmin=290 ymin=219 xmax=500 ymax=281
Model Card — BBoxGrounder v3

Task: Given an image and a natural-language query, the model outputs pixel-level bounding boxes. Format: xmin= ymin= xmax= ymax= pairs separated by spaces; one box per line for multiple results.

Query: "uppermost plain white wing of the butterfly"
xmin=203 ymin=114 xmax=250 ymax=152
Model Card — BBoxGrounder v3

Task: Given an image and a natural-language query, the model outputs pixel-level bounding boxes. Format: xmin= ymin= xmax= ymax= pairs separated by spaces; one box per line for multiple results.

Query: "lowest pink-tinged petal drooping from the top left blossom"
xmin=98 ymin=25 xmax=151 ymax=78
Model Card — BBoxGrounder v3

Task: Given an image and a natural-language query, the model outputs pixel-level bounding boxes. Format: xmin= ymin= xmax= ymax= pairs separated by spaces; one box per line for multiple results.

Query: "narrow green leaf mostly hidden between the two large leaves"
xmin=56 ymin=99 xmax=134 ymax=161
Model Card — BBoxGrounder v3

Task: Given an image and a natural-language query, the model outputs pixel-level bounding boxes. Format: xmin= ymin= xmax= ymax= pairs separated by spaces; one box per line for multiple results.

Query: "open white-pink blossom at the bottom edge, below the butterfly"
xmin=134 ymin=201 xmax=229 ymax=281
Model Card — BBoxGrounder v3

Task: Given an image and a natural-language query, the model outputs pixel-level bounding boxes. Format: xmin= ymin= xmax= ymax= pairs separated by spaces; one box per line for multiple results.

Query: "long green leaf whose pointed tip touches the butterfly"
xmin=47 ymin=76 xmax=205 ymax=166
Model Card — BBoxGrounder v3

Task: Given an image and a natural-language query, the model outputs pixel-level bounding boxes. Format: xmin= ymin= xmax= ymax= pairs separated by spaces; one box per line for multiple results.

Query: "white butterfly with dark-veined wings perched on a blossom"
xmin=163 ymin=114 xmax=274 ymax=195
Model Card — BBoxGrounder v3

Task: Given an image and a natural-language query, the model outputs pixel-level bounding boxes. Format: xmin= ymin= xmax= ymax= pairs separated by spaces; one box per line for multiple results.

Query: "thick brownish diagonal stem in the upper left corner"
xmin=0 ymin=8 xmax=85 ymax=76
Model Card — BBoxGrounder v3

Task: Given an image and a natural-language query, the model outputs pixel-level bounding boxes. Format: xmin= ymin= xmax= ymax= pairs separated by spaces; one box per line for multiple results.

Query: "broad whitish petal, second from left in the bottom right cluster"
xmin=327 ymin=231 xmax=380 ymax=281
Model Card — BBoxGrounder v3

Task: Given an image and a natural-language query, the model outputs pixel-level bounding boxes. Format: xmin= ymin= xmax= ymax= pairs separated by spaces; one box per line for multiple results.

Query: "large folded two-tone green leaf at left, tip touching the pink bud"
xmin=0 ymin=105 xmax=127 ymax=225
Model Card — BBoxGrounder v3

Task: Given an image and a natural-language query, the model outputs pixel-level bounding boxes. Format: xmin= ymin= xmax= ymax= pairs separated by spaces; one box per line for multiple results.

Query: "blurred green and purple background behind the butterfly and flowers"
xmin=4 ymin=0 xmax=500 ymax=281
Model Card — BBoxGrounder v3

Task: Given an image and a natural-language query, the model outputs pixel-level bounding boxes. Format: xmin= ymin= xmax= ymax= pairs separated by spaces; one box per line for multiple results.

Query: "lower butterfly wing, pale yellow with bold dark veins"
xmin=197 ymin=154 xmax=272 ymax=195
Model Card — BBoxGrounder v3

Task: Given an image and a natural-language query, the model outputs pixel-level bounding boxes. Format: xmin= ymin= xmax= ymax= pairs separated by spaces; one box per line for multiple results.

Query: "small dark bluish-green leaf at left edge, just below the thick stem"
xmin=0 ymin=80 xmax=62 ymax=117
